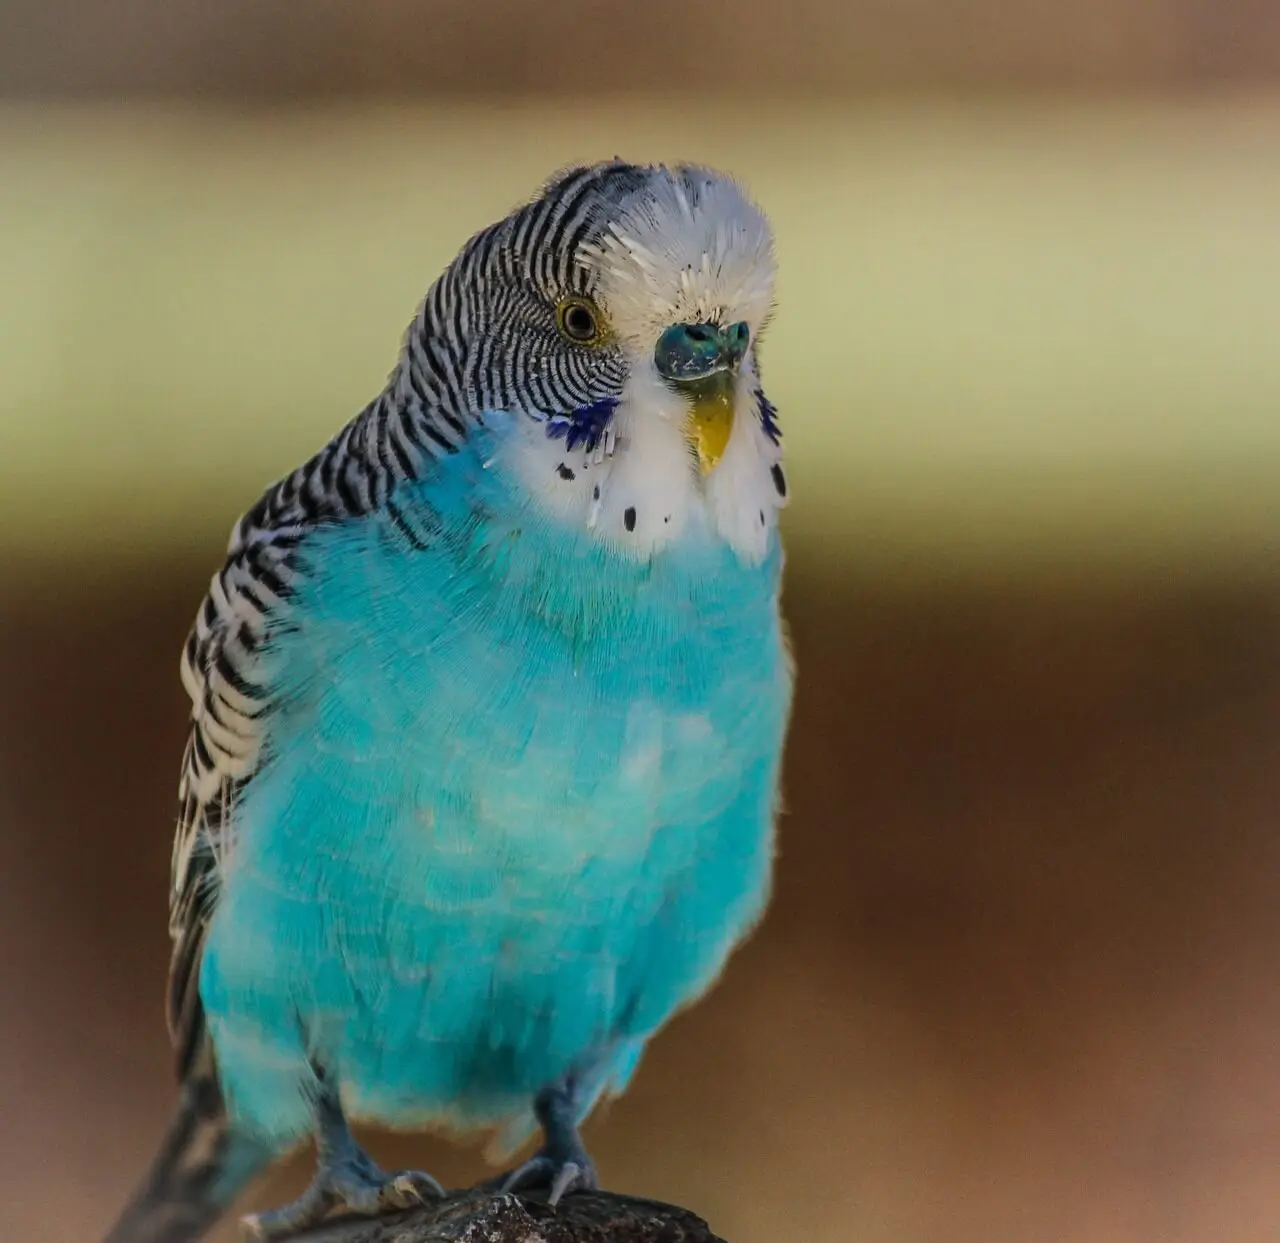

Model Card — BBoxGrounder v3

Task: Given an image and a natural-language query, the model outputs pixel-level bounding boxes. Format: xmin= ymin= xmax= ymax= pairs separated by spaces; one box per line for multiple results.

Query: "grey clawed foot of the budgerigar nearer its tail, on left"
xmin=241 ymin=1148 xmax=444 ymax=1240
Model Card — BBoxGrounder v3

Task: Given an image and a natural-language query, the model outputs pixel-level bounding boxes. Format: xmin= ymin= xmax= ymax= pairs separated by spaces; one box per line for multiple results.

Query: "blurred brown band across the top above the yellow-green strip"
xmin=0 ymin=0 xmax=1280 ymax=101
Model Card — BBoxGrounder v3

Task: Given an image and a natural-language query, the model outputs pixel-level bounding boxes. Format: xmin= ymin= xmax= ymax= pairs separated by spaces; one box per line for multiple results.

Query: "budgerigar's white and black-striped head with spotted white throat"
xmin=394 ymin=160 xmax=785 ymax=545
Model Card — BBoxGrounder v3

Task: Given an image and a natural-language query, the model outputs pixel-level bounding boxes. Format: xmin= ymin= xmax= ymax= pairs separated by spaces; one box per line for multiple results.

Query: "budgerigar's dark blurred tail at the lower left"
xmin=104 ymin=1074 xmax=274 ymax=1243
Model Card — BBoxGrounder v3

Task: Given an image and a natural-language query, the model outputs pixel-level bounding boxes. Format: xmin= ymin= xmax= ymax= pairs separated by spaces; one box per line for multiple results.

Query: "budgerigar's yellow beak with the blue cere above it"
xmin=653 ymin=323 xmax=751 ymax=475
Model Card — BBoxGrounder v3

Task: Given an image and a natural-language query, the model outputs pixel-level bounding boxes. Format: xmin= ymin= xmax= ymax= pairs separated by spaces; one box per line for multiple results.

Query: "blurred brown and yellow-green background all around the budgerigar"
xmin=0 ymin=0 xmax=1280 ymax=1243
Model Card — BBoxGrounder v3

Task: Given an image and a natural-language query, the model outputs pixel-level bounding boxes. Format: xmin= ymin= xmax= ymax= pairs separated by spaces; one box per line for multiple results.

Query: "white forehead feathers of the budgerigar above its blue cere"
xmin=584 ymin=165 xmax=774 ymax=351
